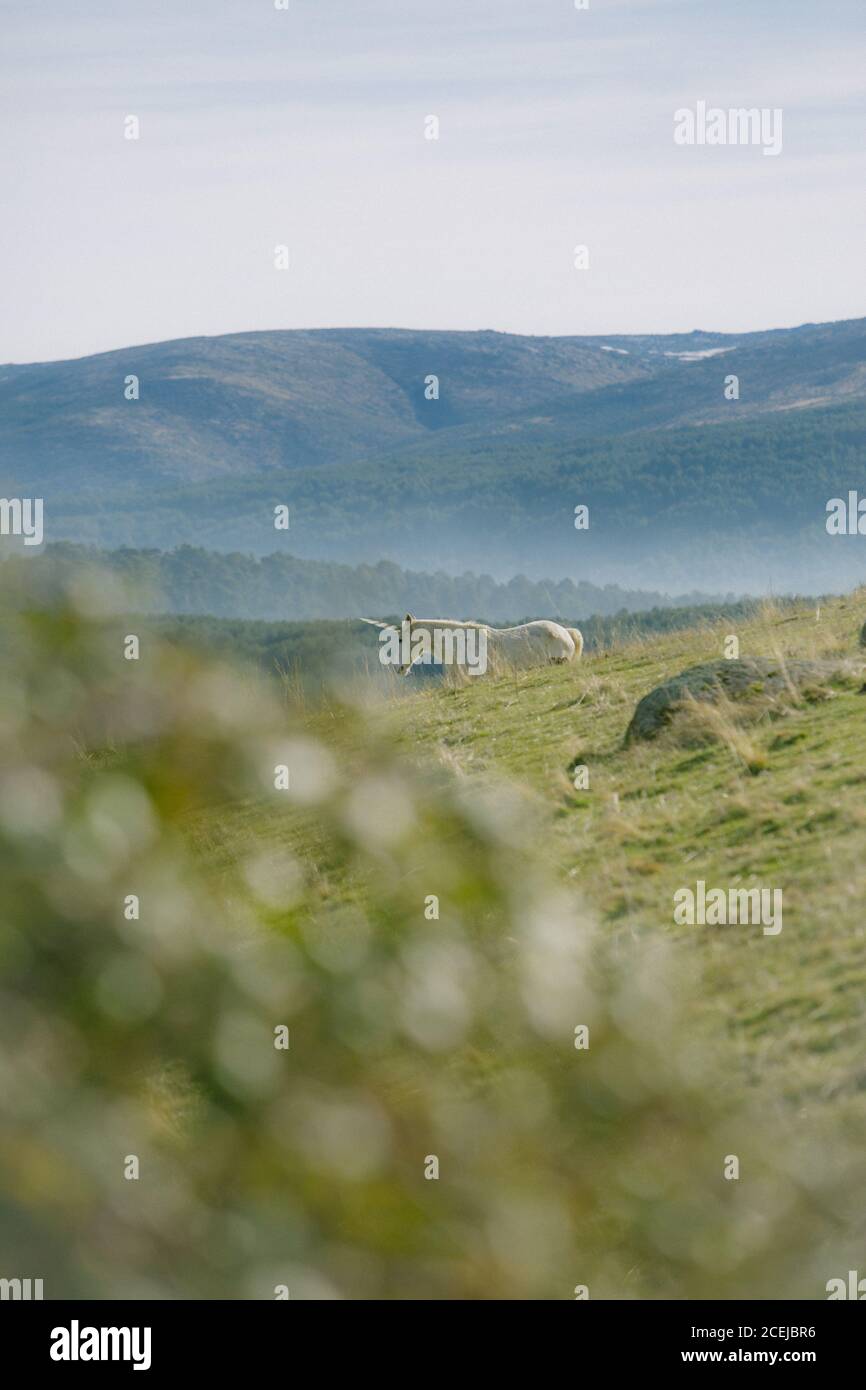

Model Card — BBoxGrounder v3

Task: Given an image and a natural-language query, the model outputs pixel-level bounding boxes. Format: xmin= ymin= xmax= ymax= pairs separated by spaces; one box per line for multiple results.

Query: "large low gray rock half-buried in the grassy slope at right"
xmin=626 ymin=656 xmax=856 ymax=744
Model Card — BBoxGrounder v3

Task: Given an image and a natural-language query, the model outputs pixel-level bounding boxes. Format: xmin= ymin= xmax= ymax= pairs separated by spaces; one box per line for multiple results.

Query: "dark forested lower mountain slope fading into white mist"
xmin=22 ymin=402 xmax=866 ymax=592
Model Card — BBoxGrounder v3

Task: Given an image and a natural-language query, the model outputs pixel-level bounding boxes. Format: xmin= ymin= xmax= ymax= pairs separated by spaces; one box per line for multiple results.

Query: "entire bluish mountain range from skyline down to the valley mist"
xmin=0 ymin=320 xmax=866 ymax=591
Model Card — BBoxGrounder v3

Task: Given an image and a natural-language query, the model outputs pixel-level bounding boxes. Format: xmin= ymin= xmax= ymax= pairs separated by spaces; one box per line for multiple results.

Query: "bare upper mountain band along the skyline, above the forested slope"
xmin=0 ymin=320 xmax=866 ymax=489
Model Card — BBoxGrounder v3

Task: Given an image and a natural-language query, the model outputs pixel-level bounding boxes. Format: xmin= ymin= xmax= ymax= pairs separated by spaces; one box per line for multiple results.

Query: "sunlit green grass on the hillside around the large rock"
xmin=203 ymin=596 xmax=866 ymax=1126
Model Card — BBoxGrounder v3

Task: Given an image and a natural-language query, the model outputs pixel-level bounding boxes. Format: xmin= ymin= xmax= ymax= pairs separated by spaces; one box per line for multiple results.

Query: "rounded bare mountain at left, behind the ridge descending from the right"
xmin=0 ymin=329 xmax=645 ymax=487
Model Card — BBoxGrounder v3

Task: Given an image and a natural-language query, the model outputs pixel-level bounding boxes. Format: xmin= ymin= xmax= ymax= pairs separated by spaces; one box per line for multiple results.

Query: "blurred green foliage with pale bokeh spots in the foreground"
xmin=0 ymin=585 xmax=863 ymax=1300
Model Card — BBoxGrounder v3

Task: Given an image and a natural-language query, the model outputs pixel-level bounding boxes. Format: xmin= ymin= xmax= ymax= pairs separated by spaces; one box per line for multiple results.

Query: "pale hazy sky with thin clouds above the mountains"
xmin=0 ymin=0 xmax=866 ymax=361
